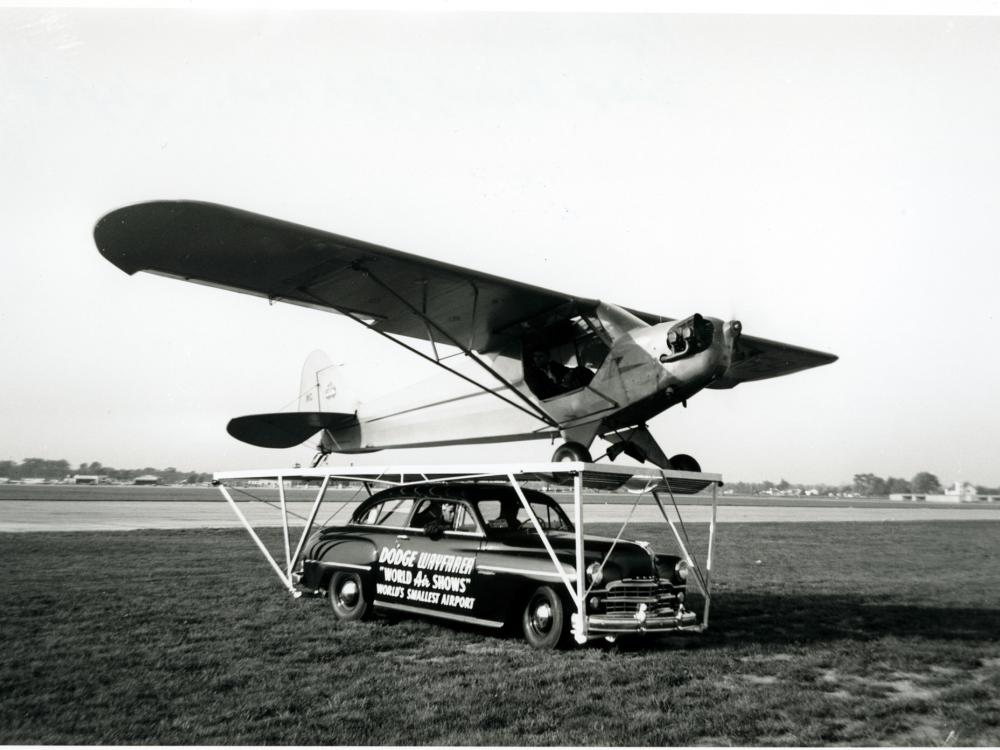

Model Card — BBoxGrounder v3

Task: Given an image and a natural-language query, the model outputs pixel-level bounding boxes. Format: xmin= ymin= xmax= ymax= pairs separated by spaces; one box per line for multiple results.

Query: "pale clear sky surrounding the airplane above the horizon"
xmin=0 ymin=8 xmax=1000 ymax=486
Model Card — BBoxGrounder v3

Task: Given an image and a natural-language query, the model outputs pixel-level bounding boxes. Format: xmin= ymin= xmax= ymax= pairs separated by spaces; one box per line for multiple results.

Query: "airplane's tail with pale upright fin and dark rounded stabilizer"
xmin=226 ymin=351 xmax=358 ymax=448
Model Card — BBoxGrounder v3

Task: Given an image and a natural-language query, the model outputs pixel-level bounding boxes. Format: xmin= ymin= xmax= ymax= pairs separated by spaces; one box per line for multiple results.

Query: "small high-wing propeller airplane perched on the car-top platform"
xmin=94 ymin=201 xmax=837 ymax=471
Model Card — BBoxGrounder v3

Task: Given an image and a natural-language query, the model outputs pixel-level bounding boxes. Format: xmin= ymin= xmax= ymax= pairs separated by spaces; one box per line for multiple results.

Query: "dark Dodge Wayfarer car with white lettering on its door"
xmin=294 ymin=483 xmax=697 ymax=649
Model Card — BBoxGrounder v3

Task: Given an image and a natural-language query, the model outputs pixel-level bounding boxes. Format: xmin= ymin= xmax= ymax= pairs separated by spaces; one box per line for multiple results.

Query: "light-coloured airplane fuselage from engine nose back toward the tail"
xmin=324 ymin=304 xmax=738 ymax=452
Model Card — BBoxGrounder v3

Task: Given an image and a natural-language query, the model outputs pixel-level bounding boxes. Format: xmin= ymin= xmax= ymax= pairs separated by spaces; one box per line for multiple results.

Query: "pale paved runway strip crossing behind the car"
xmin=0 ymin=498 xmax=1000 ymax=532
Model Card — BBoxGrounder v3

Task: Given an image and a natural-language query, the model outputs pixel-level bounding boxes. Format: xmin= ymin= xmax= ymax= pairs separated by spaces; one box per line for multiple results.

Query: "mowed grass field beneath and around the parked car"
xmin=0 ymin=522 xmax=1000 ymax=746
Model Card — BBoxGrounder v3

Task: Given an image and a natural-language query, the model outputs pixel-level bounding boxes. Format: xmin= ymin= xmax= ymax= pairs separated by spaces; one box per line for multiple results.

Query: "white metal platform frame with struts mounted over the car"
xmin=213 ymin=461 xmax=722 ymax=643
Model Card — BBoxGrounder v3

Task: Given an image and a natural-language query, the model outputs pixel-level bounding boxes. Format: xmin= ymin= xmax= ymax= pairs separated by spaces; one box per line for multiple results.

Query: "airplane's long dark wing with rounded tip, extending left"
xmin=94 ymin=201 xmax=596 ymax=352
